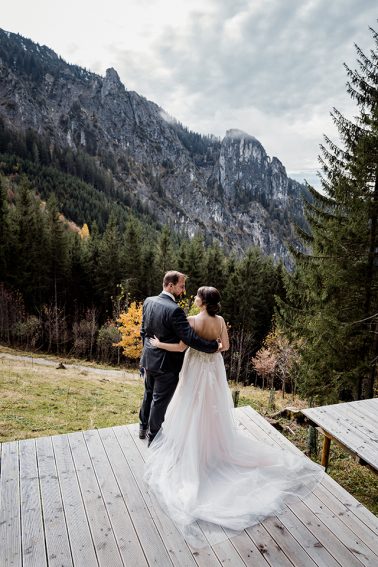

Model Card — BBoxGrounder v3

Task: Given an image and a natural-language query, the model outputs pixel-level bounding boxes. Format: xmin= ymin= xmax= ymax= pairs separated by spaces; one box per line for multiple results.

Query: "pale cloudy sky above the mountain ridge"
xmin=0 ymin=0 xmax=378 ymax=186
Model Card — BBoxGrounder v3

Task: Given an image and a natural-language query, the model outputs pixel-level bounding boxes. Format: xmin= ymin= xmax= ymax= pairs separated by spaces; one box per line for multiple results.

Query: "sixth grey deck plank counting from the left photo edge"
xmin=84 ymin=431 xmax=148 ymax=567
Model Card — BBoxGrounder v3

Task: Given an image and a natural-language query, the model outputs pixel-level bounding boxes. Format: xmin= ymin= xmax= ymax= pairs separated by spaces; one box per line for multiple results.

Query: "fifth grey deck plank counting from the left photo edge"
xmin=68 ymin=432 xmax=123 ymax=567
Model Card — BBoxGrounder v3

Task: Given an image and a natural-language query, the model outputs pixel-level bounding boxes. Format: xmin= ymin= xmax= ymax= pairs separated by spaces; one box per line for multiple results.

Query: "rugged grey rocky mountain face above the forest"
xmin=0 ymin=30 xmax=305 ymax=263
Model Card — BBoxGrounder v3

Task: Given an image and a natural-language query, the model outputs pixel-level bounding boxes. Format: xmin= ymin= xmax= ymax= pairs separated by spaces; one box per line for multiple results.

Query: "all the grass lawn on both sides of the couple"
xmin=0 ymin=347 xmax=378 ymax=515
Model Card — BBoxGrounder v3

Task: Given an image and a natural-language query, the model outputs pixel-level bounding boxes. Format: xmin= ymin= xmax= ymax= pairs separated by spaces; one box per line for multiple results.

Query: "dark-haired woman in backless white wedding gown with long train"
xmin=144 ymin=287 xmax=323 ymax=547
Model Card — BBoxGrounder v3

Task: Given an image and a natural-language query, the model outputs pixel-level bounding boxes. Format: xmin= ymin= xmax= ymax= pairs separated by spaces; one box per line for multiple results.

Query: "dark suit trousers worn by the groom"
xmin=139 ymin=370 xmax=179 ymax=441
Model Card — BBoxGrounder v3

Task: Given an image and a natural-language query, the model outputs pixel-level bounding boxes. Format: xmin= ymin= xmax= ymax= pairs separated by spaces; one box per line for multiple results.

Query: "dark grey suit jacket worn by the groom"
xmin=140 ymin=293 xmax=218 ymax=374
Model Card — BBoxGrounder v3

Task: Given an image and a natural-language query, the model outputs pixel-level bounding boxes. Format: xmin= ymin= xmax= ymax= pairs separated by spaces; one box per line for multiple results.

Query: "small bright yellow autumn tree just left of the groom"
xmin=114 ymin=301 xmax=142 ymax=360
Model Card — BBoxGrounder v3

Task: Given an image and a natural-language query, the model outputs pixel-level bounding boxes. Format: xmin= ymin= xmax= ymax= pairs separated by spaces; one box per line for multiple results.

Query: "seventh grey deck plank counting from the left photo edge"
xmin=99 ymin=428 xmax=172 ymax=567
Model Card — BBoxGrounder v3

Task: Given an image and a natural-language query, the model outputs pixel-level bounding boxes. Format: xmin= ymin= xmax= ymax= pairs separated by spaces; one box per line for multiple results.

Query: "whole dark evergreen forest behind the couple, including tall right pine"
xmin=0 ymin=30 xmax=378 ymax=405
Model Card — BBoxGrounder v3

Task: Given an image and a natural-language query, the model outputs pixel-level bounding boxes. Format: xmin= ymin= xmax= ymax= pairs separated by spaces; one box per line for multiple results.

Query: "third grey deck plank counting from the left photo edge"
xmin=36 ymin=437 xmax=73 ymax=567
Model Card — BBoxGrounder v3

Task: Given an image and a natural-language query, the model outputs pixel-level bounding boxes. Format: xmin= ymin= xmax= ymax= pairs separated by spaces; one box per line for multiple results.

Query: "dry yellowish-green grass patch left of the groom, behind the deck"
xmin=0 ymin=359 xmax=143 ymax=442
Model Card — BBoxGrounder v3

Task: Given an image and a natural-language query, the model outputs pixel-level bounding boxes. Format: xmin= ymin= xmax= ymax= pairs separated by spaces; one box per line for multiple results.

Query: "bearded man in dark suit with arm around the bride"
xmin=139 ymin=271 xmax=218 ymax=445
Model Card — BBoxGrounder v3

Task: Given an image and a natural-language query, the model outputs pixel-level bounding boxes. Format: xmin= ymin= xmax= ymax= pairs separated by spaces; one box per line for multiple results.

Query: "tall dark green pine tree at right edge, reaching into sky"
xmin=280 ymin=30 xmax=378 ymax=402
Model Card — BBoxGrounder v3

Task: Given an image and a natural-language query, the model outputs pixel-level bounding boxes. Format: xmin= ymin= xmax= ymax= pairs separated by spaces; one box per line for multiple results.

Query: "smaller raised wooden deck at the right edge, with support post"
xmin=302 ymin=398 xmax=378 ymax=472
